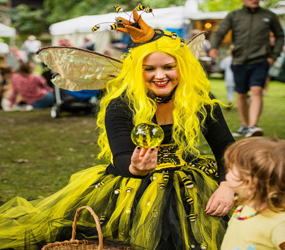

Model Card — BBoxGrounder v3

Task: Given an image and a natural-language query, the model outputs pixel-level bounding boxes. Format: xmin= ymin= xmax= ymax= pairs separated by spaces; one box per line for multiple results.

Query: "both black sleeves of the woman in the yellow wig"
xmin=105 ymin=95 xmax=234 ymax=181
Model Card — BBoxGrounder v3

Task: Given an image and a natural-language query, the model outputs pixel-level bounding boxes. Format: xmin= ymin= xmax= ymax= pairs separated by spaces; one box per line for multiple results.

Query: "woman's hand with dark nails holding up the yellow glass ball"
xmin=129 ymin=147 xmax=158 ymax=176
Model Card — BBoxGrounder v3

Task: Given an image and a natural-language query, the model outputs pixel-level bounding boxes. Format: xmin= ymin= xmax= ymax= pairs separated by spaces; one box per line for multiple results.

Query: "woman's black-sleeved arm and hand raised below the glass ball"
xmin=105 ymin=98 xmax=158 ymax=177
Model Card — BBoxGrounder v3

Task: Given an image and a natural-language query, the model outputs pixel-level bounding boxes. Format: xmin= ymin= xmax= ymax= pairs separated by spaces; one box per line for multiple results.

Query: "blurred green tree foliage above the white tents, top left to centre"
xmin=6 ymin=0 xmax=185 ymax=35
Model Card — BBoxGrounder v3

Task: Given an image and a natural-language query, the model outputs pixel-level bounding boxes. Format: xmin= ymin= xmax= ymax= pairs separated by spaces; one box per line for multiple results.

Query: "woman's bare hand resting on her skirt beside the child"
xmin=205 ymin=181 xmax=234 ymax=216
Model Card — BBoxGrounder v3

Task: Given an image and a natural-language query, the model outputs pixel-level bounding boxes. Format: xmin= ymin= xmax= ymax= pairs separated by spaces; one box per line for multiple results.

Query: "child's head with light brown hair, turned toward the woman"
xmin=224 ymin=137 xmax=285 ymax=212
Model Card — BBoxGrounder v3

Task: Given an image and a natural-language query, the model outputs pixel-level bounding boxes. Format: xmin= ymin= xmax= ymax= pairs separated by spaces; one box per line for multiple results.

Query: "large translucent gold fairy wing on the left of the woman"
xmin=36 ymin=46 xmax=122 ymax=91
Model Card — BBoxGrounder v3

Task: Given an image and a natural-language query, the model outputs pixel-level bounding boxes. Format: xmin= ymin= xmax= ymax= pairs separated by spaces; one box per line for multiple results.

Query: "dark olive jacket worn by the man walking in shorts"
xmin=211 ymin=6 xmax=284 ymax=64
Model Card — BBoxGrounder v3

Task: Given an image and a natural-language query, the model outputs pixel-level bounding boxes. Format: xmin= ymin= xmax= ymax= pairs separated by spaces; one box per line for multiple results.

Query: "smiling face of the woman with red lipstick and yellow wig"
xmin=143 ymin=52 xmax=179 ymax=96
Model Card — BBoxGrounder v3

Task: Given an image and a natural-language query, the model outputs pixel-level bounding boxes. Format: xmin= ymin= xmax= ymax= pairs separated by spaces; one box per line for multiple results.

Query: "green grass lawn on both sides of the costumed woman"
xmin=0 ymin=80 xmax=285 ymax=202
